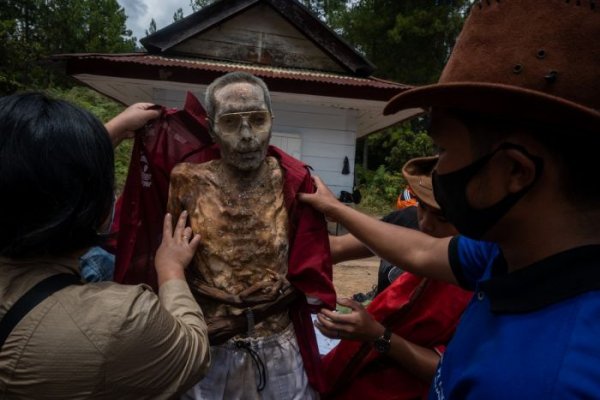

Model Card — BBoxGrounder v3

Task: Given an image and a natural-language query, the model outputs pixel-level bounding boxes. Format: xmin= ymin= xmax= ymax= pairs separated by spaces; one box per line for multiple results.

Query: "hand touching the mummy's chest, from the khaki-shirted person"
xmin=154 ymin=211 xmax=200 ymax=286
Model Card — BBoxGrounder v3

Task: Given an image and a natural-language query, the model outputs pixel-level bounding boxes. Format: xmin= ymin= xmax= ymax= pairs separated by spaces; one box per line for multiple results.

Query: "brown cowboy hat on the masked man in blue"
xmin=383 ymin=0 xmax=600 ymax=133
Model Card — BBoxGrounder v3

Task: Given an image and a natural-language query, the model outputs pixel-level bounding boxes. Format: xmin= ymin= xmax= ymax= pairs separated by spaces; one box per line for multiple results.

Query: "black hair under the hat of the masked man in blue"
xmin=450 ymin=110 xmax=600 ymax=210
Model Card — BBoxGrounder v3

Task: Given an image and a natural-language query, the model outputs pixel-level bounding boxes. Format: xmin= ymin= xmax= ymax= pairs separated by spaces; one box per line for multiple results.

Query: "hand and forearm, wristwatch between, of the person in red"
xmin=315 ymin=299 xmax=440 ymax=383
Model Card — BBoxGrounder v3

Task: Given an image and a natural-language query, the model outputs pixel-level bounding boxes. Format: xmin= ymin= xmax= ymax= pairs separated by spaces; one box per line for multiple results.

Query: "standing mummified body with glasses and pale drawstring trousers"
xmin=168 ymin=72 xmax=318 ymax=400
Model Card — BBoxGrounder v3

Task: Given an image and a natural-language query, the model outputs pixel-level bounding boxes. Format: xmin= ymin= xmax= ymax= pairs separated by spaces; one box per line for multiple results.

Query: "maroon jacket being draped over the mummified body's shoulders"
xmin=115 ymin=93 xmax=335 ymax=391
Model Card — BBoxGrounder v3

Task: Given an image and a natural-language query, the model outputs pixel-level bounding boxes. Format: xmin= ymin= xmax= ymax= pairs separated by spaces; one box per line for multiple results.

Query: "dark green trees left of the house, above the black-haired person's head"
xmin=0 ymin=0 xmax=136 ymax=93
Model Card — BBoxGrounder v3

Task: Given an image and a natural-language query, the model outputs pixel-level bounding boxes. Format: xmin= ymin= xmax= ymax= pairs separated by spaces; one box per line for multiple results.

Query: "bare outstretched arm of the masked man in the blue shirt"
xmin=298 ymin=176 xmax=456 ymax=284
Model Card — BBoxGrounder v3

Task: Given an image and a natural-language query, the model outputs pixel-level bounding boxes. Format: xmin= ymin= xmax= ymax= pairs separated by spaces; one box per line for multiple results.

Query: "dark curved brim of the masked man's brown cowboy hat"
xmin=383 ymin=82 xmax=600 ymax=132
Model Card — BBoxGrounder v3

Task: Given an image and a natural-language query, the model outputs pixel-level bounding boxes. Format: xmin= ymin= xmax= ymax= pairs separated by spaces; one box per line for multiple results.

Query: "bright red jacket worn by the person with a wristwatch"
xmin=323 ymin=272 xmax=472 ymax=400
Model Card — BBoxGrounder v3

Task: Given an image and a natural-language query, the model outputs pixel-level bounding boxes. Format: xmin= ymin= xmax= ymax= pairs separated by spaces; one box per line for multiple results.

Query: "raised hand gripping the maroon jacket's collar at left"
xmin=104 ymin=103 xmax=161 ymax=147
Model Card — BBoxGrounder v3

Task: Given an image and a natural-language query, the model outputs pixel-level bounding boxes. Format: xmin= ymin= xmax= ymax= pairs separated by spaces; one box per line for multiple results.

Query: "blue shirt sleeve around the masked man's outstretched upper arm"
xmin=448 ymin=236 xmax=500 ymax=290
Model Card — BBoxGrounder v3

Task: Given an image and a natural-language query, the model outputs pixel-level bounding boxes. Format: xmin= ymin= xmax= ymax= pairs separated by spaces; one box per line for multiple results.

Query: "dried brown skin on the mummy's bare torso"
xmin=169 ymin=157 xmax=290 ymax=337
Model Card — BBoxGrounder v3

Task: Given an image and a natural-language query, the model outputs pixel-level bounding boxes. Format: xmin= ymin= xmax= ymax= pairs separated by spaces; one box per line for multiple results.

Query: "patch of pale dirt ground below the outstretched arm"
xmin=333 ymin=257 xmax=379 ymax=297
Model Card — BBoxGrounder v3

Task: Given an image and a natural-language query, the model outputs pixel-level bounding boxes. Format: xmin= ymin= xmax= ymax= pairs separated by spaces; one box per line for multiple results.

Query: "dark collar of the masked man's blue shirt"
xmin=479 ymin=245 xmax=600 ymax=314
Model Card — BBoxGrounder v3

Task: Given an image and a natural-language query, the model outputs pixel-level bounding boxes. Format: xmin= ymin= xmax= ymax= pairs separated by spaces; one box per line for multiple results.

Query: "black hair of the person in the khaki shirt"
xmin=0 ymin=93 xmax=114 ymax=258
